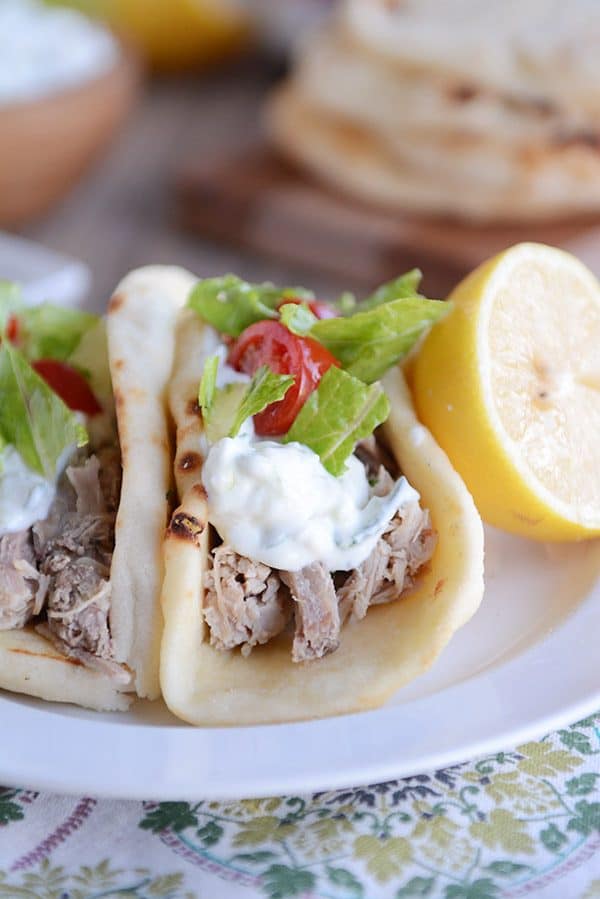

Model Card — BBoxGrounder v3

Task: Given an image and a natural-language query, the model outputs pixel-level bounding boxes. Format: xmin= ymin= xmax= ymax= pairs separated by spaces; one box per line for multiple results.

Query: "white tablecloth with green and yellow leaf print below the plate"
xmin=0 ymin=715 xmax=600 ymax=899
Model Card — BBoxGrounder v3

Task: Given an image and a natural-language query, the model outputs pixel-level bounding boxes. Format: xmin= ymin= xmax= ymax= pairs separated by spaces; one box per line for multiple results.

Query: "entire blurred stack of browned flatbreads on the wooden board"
xmin=268 ymin=0 xmax=600 ymax=222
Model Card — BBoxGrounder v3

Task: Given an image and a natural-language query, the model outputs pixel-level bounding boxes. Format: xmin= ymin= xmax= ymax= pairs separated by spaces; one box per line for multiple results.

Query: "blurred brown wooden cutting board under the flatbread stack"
xmin=176 ymin=145 xmax=600 ymax=296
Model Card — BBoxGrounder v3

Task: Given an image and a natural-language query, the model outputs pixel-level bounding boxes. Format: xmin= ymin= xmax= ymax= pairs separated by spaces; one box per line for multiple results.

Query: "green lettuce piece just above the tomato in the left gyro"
xmin=19 ymin=303 xmax=99 ymax=362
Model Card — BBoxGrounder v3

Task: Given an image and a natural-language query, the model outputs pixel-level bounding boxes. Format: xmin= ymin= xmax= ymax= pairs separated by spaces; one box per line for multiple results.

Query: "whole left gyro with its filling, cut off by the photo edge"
xmin=0 ymin=268 xmax=193 ymax=710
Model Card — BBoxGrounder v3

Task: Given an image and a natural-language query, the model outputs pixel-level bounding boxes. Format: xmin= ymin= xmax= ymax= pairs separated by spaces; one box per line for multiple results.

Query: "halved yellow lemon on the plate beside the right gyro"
xmin=412 ymin=243 xmax=600 ymax=541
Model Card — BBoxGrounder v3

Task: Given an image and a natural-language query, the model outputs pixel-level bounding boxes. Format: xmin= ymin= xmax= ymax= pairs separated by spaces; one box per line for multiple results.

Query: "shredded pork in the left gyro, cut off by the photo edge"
xmin=0 ymin=447 xmax=121 ymax=673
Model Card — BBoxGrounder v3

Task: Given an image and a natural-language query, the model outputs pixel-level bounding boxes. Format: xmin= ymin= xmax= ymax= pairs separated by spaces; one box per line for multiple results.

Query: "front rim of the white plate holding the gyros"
xmin=0 ymin=564 xmax=600 ymax=801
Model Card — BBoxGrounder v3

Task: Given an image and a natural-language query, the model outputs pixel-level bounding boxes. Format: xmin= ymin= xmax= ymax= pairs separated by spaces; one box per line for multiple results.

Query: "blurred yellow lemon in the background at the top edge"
xmin=49 ymin=0 xmax=249 ymax=71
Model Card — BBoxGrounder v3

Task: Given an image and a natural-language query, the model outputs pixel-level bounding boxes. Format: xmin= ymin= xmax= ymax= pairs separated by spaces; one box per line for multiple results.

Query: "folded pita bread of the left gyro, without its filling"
xmin=0 ymin=267 xmax=195 ymax=710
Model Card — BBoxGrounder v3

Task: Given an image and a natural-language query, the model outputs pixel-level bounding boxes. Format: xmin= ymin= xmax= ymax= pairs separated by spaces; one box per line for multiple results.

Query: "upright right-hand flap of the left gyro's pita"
xmin=107 ymin=266 xmax=197 ymax=699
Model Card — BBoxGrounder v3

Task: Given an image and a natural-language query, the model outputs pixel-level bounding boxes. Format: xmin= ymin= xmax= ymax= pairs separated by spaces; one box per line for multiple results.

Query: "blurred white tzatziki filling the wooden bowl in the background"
xmin=0 ymin=0 xmax=120 ymax=106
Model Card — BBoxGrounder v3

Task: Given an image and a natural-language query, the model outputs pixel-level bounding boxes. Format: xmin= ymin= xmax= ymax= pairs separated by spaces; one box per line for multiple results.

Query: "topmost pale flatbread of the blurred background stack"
xmin=340 ymin=0 xmax=600 ymax=117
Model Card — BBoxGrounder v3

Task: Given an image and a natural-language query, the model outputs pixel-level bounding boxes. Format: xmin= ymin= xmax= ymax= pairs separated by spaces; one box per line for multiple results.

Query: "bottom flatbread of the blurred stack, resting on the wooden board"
xmin=267 ymin=84 xmax=600 ymax=222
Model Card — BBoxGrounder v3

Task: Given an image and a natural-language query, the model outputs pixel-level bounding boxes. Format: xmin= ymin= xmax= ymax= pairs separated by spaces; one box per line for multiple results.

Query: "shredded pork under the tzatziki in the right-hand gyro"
xmin=204 ymin=438 xmax=436 ymax=662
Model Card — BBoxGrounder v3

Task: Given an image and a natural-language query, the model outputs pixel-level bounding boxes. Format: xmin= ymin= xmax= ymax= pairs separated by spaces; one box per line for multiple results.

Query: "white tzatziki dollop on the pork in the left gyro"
xmin=0 ymin=446 xmax=56 ymax=536
